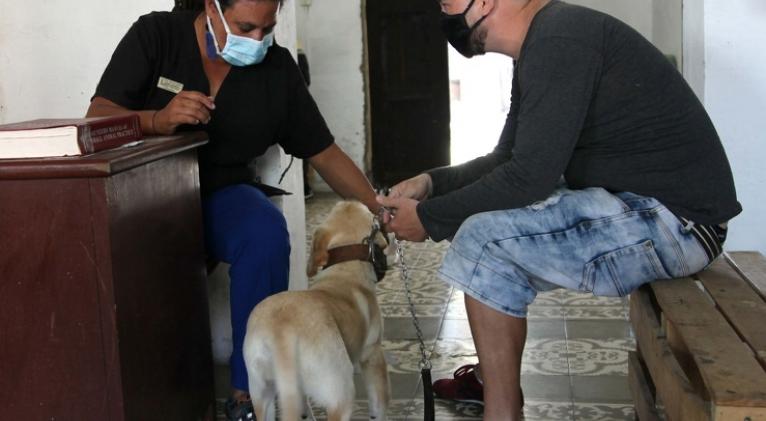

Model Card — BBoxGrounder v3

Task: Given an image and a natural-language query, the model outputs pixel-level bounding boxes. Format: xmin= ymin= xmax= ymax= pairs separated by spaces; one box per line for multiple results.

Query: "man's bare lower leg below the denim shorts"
xmin=465 ymin=296 xmax=527 ymax=420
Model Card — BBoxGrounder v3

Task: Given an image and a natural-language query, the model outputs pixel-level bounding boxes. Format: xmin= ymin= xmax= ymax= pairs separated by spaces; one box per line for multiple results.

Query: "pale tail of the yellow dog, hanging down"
xmin=274 ymin=333 xmax=304 ymax=421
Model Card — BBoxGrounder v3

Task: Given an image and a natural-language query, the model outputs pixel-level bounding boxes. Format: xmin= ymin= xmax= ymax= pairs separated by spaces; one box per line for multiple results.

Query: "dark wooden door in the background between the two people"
xmin=366 ymin=0 xmax=450 ymax=186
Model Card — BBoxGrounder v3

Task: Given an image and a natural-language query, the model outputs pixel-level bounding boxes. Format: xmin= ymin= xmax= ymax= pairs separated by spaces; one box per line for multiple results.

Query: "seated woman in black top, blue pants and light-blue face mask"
xmin=88 ymin=0 xmax=378 ymax=419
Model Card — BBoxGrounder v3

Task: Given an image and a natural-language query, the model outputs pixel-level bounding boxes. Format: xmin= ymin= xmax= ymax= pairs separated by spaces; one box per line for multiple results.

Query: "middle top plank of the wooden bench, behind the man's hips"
xmin=698 ymin=260 xmax=766 ymax=370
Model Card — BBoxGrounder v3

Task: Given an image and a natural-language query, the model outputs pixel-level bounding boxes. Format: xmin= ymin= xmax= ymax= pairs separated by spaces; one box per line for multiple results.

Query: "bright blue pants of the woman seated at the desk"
xmin=202 ymin=184 xmax=290 ymax=391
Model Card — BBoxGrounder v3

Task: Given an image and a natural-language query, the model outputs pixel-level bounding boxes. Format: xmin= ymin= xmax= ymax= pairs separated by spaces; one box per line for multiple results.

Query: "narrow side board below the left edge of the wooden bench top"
xmin=630 ymin=287 xmax=710 ymax=421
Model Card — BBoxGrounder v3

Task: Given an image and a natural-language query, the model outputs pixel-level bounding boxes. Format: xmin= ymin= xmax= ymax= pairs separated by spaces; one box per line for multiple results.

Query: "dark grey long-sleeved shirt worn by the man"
xmin=417 ymin=0 xmax=742 ymax=241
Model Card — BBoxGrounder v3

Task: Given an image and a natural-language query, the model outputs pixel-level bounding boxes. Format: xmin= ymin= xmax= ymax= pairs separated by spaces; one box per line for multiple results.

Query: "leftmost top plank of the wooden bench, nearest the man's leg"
xmin=651 ymin=278 xmax=766 ymax=407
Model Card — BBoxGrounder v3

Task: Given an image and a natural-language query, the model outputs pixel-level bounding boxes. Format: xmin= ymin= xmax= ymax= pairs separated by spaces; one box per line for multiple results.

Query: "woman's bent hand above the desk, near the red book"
xmin=152 ymin=91 xmax=215 ymax=134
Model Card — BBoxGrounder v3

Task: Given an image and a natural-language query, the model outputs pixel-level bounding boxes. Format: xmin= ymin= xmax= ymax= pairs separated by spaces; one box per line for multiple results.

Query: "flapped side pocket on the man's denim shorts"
xmin=583 ymin=240 xmax=670 ymax=297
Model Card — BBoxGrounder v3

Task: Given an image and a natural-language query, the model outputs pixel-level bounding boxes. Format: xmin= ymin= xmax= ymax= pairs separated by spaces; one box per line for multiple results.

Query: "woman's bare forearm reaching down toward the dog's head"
xmin=309 ymin=144 xmax=380 ymax=213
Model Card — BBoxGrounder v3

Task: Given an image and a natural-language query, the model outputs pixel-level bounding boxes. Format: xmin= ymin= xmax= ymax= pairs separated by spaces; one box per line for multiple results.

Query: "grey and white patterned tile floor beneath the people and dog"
xmin=214 ymin=194 xmax=635 ymax=421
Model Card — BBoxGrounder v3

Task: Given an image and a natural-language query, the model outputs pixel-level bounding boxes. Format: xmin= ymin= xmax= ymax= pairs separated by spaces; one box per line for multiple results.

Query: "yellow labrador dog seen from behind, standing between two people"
xmin=244 ymin=201 xmax=390 ymax=421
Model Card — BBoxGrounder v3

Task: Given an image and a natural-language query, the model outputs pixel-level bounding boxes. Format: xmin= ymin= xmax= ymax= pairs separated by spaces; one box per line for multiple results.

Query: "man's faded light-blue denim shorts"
xmin=439 ymin=188 xmax=710 ymax=317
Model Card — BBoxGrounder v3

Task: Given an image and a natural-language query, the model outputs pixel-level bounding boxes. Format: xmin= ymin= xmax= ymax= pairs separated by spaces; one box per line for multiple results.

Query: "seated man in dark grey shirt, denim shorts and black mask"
xmin=378 ymin=0 xmax=742 ymax=420
